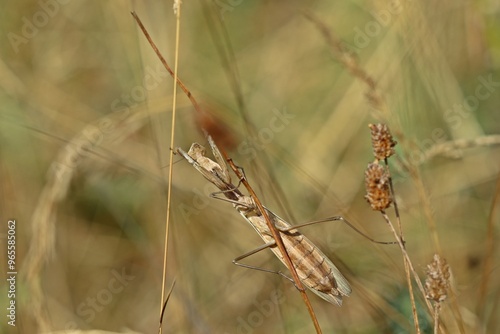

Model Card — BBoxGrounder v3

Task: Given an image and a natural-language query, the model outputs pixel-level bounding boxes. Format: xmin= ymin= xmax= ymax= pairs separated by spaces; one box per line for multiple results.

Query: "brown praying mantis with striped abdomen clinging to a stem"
xmin=177 ymin=134 xmax=387 ymax=306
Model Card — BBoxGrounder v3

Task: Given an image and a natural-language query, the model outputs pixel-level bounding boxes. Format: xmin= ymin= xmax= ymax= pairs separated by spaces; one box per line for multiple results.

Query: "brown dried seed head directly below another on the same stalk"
xmin=365 ymin=163 xmax=392 ymax=211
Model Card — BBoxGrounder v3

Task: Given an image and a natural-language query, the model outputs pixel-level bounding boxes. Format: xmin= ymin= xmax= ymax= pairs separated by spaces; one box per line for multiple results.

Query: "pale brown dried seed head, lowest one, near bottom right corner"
xmin=425 ymin=254 xmax=451 ymax=303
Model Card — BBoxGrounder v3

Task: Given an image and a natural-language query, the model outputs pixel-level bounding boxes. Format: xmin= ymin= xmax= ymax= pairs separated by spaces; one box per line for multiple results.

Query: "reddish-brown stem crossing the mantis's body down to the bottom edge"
xmin=222 ymin=157 xmax=322 ymax=334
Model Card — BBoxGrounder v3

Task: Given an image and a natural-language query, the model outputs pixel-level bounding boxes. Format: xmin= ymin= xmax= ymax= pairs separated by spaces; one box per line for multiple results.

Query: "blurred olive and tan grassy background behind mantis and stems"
xmin=0 ymin=0 xmax=500 ymax=333
